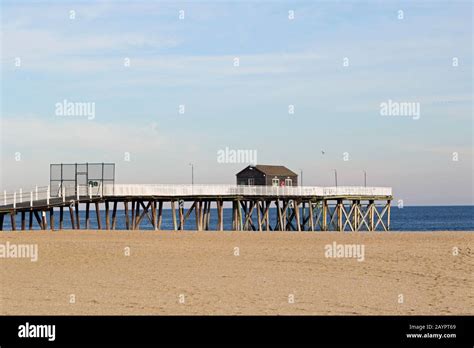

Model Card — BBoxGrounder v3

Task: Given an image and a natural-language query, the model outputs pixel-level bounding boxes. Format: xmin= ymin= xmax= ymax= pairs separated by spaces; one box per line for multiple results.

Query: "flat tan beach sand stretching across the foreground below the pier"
xmin=0 ymin=230 xmax=474 ymax=315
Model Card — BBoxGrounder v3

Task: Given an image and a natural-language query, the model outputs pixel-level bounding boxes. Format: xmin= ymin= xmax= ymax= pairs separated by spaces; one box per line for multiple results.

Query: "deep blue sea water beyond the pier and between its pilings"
xmin=3 ymin=206 xmax=474 ymax=231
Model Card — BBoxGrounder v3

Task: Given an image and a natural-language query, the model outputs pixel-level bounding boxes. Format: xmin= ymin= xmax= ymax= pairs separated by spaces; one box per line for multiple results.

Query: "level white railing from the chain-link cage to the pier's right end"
xmin=104 ymin=184 xmax=392 ymax=197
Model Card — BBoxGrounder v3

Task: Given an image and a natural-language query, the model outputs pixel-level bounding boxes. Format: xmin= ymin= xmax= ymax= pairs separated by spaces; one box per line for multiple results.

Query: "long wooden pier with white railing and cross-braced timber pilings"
xmin=0 ymin=184 xmax=392 ymax=231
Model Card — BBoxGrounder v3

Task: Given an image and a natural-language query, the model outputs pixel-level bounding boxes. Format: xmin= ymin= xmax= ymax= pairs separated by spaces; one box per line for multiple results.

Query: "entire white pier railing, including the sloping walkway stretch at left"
xmin=0 ymin=184 xmax=392 ymax=208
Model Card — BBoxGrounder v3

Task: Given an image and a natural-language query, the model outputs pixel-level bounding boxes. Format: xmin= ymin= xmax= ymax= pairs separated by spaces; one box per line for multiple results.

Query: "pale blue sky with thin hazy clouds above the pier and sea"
xmin=0 ymin=0 xmax=474 ymax=205
